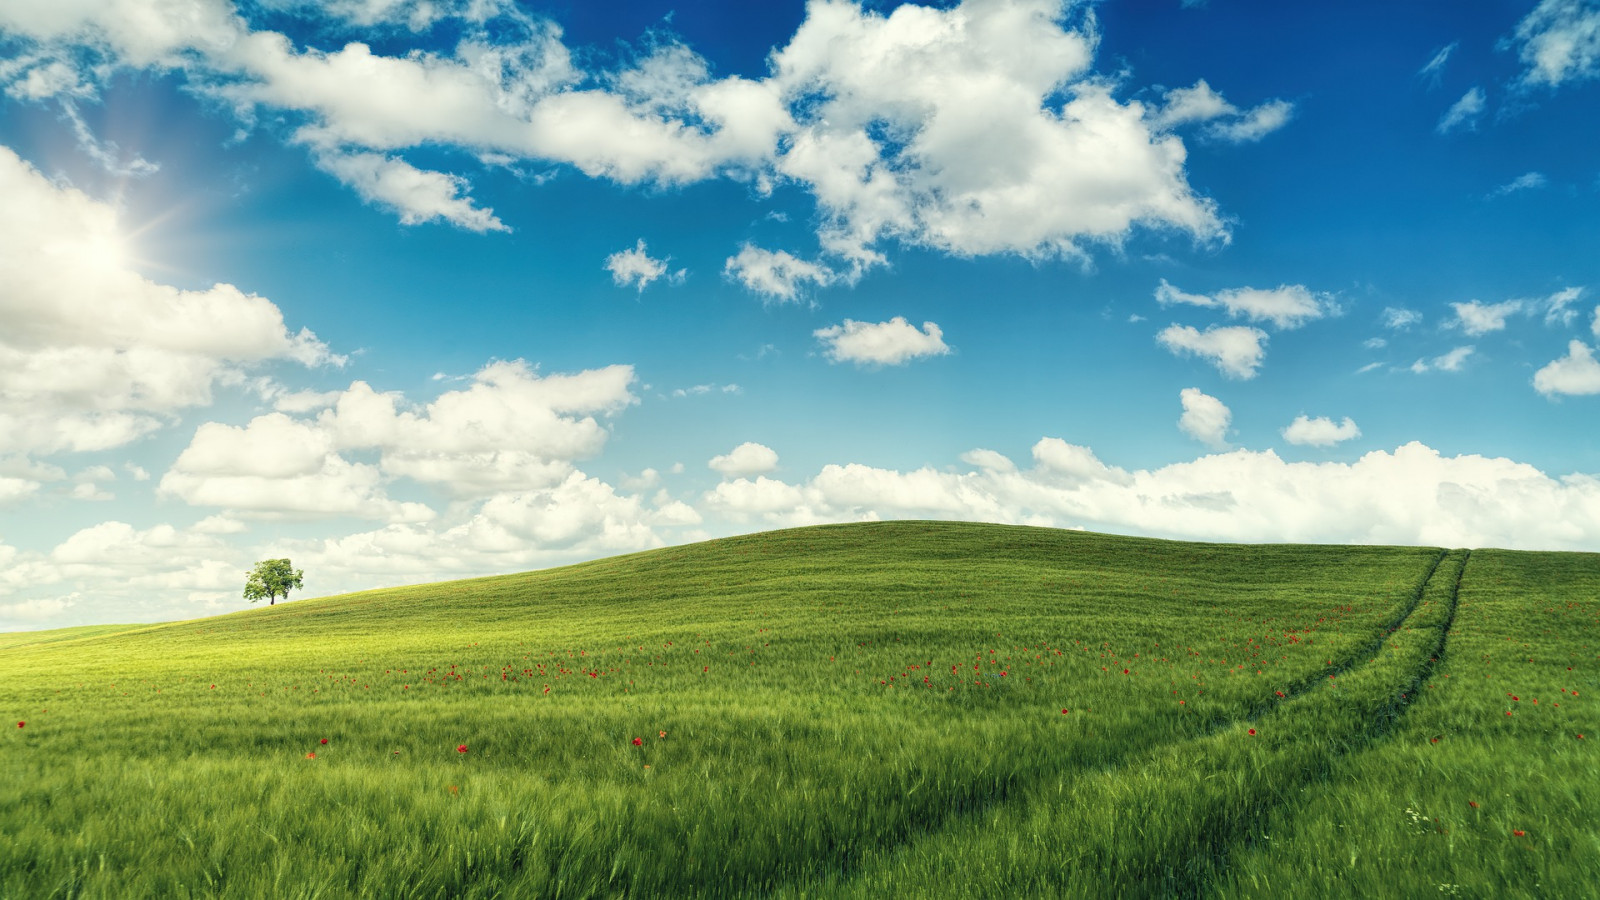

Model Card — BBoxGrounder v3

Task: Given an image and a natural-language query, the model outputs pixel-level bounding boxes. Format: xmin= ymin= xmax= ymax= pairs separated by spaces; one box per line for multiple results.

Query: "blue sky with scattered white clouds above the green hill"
xmin=0 ymin=0 xmax=1600 ymax=631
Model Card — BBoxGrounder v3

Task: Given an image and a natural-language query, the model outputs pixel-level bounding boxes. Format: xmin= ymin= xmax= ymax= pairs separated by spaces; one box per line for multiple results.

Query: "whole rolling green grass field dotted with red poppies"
xmin=0 ymin=522 xmax=1600 ymax=898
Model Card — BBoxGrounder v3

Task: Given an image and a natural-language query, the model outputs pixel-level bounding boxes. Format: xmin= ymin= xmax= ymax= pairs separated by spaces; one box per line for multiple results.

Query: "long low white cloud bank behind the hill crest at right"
xmin=706 ymin=439 xmax=1600 ymax=551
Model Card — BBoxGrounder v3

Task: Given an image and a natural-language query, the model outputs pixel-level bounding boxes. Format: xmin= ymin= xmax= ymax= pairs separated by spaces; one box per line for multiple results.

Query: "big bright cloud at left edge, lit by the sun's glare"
xmin=0 ymin=147 xmax=342 ymax=453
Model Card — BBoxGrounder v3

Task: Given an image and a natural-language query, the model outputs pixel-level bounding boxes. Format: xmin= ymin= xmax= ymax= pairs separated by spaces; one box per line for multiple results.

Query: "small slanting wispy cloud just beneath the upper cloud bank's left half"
xmin=314 ymin=151 xmax=510 ymax=232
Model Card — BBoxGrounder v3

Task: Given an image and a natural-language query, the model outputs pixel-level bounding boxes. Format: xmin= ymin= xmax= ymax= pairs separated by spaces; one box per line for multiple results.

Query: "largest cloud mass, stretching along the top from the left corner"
xmin=0 ymin=0 xmax=1235 ymax=277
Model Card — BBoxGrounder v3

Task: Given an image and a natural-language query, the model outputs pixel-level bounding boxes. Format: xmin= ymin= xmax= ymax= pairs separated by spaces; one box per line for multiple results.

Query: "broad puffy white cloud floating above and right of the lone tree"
xmin=160 ymin=360 xmax=635 ymax=512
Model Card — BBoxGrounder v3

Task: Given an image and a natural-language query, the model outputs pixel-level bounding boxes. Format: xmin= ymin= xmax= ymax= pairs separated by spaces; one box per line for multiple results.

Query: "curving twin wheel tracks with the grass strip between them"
xmin=779 ymin=551 xmax=1470 ymax=898
